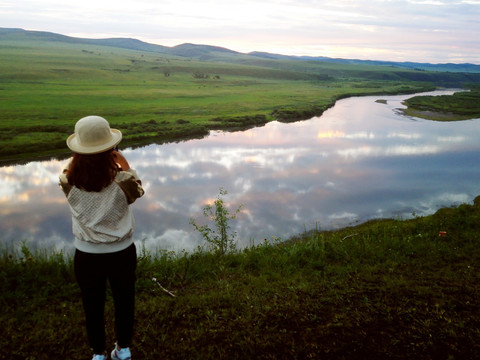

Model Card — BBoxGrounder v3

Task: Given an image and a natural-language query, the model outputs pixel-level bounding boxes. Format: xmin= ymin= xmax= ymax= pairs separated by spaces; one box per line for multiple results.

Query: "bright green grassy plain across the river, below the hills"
xmin=0 ymin=40 xmax=446 ymax=159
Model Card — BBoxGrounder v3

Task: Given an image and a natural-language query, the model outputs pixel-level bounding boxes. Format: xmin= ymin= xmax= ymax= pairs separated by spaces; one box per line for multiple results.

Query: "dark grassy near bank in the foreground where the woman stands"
xmin=0 ymin=198 xmax=480 ymax=360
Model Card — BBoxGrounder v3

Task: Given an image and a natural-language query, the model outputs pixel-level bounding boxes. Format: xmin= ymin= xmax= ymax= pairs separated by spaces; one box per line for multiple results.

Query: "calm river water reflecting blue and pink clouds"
xmin=0 ymin=91 xmax=480 ymax=251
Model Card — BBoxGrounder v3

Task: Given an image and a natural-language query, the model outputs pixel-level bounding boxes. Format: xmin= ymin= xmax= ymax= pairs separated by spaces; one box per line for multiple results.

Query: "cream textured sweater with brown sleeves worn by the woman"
xmin=60 ymin=169 xmax=144 ymax=253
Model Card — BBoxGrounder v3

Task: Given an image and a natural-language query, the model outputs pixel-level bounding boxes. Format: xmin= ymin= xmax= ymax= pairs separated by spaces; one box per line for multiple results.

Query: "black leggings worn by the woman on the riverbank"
xmin=74 ymin=244 xmax=137 ymax=354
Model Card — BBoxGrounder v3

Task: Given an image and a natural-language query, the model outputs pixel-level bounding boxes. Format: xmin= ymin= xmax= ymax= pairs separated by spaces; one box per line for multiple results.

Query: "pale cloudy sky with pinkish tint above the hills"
xmin=0 ymin=0 xmax=480 ymax=64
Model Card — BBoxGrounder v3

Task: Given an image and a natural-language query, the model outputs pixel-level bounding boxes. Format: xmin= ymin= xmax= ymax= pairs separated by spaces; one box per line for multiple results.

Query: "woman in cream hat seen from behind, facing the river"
xmin=60 ymin=116 xmax=144 ymax=360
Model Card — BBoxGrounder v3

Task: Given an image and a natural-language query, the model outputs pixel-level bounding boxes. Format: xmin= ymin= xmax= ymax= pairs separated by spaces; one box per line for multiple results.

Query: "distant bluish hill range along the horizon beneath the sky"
xmin=0 ymin=28 xmax=480 ymax=73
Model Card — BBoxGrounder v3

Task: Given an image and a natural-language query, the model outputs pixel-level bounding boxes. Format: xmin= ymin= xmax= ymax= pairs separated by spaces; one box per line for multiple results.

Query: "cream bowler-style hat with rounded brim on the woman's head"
xmin=67 ymin=115 xmax=122 ymax=154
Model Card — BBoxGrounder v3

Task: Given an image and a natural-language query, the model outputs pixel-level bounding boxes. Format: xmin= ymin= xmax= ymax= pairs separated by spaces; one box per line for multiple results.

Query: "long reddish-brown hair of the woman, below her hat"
xmin=67 ymin=150 xmax=119 ymax=192
